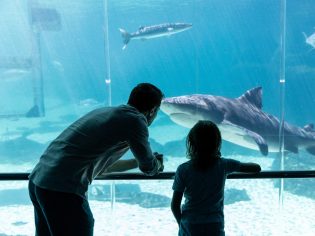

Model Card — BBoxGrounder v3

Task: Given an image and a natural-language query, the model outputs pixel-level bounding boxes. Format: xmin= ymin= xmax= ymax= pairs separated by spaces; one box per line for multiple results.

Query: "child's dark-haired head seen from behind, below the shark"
xmin=186 ymin=120 xmax=222 ymax=169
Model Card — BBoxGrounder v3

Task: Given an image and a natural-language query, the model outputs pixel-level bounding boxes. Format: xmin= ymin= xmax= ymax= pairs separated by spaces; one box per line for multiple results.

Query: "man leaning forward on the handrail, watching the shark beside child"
xmin=29 ymin=83 xmax=163 ymax=236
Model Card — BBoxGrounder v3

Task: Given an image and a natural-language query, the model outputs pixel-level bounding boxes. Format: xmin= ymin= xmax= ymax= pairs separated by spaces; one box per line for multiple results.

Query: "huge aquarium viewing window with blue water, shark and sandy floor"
xmin=0 ymin=0 xmax=315 ymax=235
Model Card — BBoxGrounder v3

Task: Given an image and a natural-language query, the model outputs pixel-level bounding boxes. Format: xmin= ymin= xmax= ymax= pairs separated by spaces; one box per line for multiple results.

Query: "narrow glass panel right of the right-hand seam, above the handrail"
xmin=284 ymin=0 xmax=315 ymax=170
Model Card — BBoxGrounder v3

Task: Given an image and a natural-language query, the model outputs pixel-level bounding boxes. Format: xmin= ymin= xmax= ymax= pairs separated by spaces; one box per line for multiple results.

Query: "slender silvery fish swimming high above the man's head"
xmin=119 ymin=23 xmax=192 ymax=50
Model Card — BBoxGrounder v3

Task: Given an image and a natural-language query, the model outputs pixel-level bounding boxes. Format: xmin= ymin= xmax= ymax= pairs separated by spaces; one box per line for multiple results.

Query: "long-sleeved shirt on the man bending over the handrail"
xmin=29 ymin=105 xmax=159 ymax=198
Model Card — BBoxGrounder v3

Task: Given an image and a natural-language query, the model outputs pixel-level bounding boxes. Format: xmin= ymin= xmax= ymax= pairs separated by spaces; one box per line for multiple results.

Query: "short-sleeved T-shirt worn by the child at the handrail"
xmin=173 ymin=158 xmax=240 ymax=223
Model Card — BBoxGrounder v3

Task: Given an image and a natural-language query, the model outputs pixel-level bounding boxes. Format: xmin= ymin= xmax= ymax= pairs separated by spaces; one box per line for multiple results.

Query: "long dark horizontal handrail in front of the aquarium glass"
xmin=0 ymin=170 xmax=315 ymax=181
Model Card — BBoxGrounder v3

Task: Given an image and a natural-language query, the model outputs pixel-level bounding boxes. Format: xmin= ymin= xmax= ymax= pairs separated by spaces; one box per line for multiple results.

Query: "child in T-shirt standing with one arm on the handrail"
xmin=171 ymin=121 xmax=261 ymax=236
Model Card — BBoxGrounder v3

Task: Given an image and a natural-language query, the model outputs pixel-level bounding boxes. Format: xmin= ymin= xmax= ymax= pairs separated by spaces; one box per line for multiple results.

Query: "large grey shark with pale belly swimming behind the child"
xmin=161 ymin=87 xmax=315 ymax=156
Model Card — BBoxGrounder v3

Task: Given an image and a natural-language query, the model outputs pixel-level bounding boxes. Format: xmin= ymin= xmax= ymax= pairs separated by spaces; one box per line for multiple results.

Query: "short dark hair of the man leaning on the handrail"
xmin=128 ymin=83 xmax=164 ymax=112
